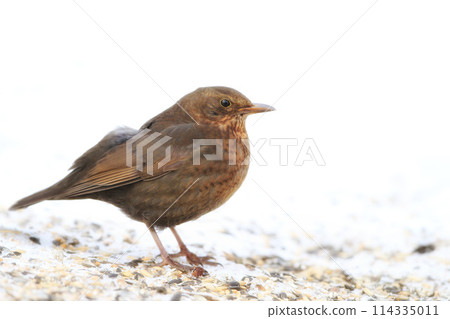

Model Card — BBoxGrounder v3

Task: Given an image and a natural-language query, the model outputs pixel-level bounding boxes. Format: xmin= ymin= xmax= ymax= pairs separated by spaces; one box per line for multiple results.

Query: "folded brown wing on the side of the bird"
xmin=58 ymin=124 xmax=193 ymax=199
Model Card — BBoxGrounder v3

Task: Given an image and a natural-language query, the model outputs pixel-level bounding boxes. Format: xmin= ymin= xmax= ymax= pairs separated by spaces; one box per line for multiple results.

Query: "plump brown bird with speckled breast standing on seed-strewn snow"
xmin=11 ymin=87 xmax=274 ymax=273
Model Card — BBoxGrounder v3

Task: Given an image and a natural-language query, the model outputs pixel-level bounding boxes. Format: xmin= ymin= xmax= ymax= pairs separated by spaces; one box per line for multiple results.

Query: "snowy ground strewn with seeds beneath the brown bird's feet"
xmin=0 ymin=195 xmax=450 ymax=300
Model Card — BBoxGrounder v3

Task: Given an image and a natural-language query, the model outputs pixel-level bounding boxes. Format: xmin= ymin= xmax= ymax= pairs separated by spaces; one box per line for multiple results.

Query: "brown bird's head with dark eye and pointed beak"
xmin=177 ymin=86 xmax=275 ymax=125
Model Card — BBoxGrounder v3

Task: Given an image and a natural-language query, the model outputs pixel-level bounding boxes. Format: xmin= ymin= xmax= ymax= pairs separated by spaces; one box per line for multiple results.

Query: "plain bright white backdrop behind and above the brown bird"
xmin=0 ymin=0 xmax=450 ymax=290
